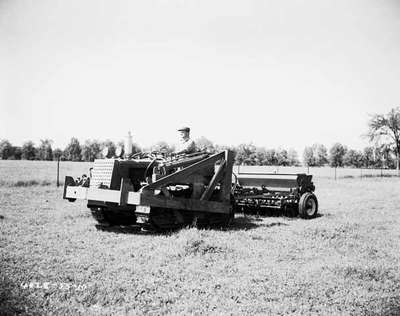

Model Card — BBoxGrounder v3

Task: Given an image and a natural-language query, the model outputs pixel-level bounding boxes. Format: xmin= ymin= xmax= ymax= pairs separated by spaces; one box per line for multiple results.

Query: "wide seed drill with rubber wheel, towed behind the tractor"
xmin=234 ymin=173 xmax=318 ymax=219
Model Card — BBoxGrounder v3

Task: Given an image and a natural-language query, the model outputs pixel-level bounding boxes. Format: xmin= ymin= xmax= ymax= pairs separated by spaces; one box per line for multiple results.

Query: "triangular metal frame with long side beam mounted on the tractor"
xmin=64 ymin=150 xmax=233 ymax=214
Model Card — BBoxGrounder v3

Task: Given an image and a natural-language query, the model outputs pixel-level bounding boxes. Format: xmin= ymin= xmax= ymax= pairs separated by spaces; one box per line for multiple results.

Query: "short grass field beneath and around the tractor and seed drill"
xmin=0 ymin=162 xmax=400 ymax=315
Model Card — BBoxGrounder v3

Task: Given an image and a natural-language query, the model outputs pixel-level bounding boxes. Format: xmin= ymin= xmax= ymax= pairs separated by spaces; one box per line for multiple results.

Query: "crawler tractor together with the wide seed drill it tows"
xmin=63 ymin=150 xmax=318 ymax=231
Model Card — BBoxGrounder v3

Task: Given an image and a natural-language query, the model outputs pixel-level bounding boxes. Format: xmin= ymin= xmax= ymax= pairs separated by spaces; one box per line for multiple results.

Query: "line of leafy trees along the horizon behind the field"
xmin=0 ymin=107 xmax=400 ymax=168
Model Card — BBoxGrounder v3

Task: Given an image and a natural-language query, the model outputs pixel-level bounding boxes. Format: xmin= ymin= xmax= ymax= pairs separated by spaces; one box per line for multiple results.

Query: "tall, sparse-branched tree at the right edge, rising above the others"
xmin=367 ymin=107 xmax=400 ymax=170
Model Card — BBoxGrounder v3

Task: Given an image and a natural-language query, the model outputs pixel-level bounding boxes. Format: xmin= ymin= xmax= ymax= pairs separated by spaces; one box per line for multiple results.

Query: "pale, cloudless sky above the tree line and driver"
xmin=0 ymin=0 xmax=400 ymax=152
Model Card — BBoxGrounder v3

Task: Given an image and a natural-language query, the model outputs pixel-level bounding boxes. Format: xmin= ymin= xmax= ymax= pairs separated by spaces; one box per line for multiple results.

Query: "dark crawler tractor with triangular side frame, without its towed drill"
xmin=64 ymin=151 xmax=234 ymax=231
